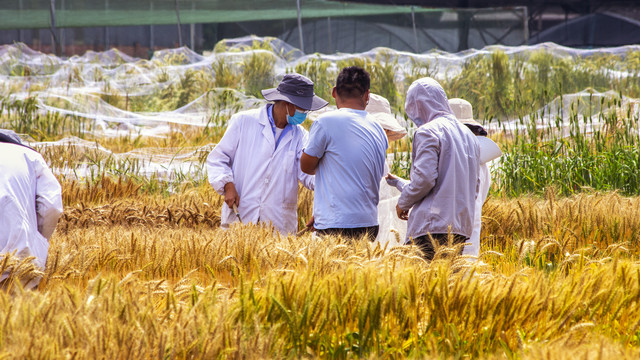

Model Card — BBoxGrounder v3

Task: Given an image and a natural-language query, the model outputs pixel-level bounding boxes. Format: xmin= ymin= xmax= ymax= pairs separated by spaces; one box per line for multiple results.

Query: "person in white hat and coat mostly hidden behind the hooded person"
xmin=449 ymin=98 xmax=502 ymax=258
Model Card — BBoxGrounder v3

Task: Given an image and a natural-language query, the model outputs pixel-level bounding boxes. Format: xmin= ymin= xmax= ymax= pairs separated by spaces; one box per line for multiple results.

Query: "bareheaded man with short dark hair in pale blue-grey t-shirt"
xmin=300 ymin=66 xmax=388 ymax=241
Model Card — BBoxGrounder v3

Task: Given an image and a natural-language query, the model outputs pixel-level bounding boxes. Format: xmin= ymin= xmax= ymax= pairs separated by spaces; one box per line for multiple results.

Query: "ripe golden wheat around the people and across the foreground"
xmin=0 ymin=179 xmax=640 ymax=359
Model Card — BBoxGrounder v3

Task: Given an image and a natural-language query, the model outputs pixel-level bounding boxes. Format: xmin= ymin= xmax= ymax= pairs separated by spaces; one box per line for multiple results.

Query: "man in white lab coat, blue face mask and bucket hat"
xmin=207 ymin=73 xmax=328 ymax=234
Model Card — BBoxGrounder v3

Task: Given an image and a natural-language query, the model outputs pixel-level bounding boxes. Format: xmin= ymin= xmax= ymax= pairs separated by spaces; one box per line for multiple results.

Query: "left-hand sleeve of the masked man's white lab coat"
xmin=207 ymin=117 xmax=241 ymax=195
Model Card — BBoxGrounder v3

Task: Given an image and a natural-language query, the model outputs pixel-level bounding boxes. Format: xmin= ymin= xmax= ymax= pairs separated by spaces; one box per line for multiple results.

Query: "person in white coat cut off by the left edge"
xmin=0 ymin=130 xmax=62 ymax=288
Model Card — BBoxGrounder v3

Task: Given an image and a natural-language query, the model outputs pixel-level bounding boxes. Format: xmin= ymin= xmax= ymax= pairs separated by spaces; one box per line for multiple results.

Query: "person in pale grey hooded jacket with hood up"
xmin=388 ymin=78 xmax=479 ymax=260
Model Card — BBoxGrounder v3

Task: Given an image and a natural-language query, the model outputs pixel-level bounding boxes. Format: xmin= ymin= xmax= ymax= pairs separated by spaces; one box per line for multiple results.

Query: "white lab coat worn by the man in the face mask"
xmin=207 ymin=106 xmax=314 ymax=233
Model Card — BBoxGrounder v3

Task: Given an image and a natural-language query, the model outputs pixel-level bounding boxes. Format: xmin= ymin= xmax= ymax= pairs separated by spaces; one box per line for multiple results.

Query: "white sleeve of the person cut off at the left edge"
xmin=35 ymin=155 xmax=62 ymax=240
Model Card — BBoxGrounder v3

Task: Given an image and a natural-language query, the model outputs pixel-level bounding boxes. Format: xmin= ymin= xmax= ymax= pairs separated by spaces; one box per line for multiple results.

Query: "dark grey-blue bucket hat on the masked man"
xmin=261 ymin=73 xmax=329 ymax=110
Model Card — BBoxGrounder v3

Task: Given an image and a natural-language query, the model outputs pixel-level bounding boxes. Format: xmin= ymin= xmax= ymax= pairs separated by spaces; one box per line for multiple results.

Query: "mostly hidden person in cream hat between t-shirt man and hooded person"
xmin=365 ymin=94 xmax=407 ymax=245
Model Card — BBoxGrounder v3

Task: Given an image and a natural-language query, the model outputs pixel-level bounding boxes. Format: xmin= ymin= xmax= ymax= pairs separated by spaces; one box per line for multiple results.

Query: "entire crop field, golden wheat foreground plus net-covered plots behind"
xmin=0 ymin=42 xmax=640 ymax=360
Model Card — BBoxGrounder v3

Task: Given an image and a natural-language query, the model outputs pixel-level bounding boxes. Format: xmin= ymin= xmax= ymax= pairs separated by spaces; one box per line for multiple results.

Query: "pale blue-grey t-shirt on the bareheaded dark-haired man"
xmin=304 ymin=108 xmax=389 ymax=230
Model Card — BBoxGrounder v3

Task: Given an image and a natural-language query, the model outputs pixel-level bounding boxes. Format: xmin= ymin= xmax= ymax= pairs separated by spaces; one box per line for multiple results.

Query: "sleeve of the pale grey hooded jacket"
xmin=398 ymin=131 xmax=440 ymax=210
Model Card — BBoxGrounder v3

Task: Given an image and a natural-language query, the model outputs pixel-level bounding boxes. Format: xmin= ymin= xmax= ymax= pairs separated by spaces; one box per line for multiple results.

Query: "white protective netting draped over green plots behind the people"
xmin=0 ymin=37 xmax=640 ymax=183
